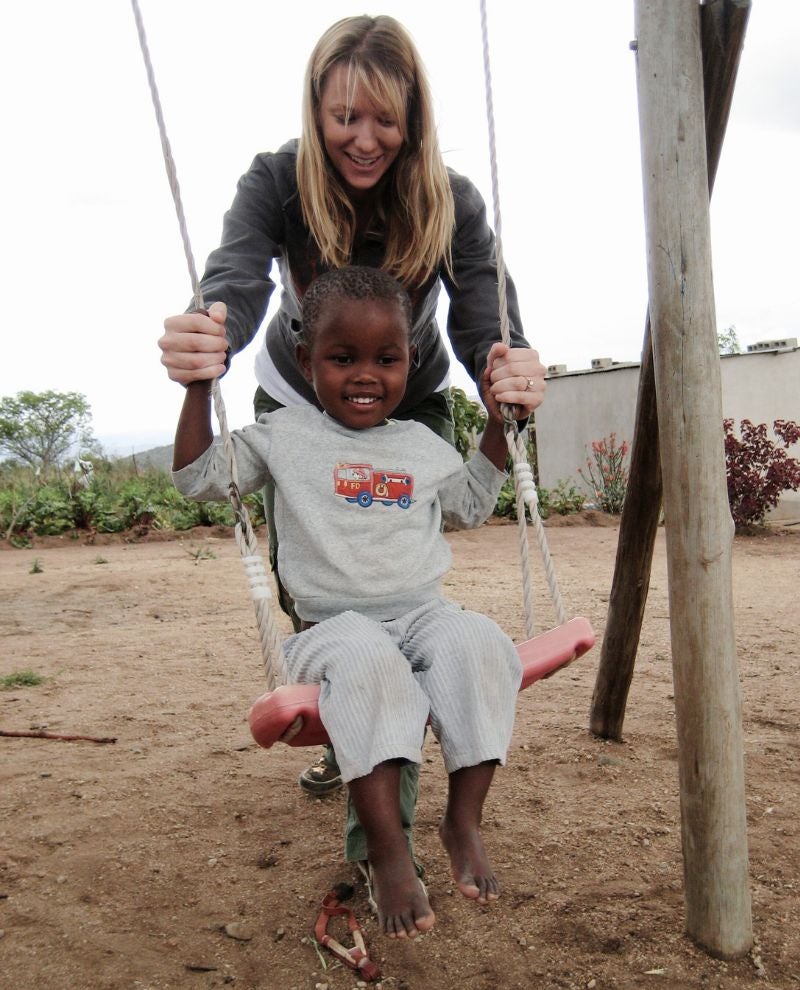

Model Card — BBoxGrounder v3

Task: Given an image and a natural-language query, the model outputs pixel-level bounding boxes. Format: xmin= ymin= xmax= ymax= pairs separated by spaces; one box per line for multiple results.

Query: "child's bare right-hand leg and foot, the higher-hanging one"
xmin=439 ymin=761 xmax=500 ymax=904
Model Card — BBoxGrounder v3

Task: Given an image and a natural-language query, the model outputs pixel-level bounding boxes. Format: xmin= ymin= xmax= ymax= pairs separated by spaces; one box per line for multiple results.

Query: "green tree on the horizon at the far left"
xmin=0 ymin=391 xmax=97 ymax=474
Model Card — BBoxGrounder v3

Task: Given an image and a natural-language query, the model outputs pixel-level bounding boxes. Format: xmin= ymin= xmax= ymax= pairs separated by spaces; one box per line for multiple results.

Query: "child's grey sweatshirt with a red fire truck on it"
xmin=173 ymin=406 xmax=505 ymax=622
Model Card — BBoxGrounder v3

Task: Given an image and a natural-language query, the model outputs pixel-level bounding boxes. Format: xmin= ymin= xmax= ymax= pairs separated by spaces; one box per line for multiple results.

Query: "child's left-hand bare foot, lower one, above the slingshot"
xmin=370 ymin=853 xmax=436 ymax=938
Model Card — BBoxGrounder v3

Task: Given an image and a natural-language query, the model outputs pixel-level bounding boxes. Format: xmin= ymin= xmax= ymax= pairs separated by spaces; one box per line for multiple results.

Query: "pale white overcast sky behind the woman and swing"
xmin=0 ymin=0 xmax=800 ymax=453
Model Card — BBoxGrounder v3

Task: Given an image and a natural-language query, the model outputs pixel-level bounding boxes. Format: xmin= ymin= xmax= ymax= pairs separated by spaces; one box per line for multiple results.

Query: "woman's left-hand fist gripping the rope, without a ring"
xmin=158 ymin=302 xmax=228 ymax=385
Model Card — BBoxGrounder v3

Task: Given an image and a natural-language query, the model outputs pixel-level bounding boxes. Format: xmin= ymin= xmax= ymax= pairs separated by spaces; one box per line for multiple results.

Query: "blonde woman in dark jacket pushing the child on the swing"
xmin=159 ymin=16 xmax=545 ymax=844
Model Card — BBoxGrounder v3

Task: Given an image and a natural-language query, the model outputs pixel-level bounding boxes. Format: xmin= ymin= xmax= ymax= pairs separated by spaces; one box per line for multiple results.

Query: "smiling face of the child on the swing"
xmin=297 ymin=299 xmax=411 ymax=430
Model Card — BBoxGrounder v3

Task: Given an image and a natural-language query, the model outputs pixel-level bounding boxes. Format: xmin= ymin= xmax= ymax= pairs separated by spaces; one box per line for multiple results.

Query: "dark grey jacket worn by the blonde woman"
xmin=197 ymin=140 xmax=527 ymax=414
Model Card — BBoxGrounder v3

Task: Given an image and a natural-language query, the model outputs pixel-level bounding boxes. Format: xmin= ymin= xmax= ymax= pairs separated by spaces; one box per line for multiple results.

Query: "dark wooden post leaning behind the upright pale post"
xmin=589 ymin=0 xmax=750 ymax=740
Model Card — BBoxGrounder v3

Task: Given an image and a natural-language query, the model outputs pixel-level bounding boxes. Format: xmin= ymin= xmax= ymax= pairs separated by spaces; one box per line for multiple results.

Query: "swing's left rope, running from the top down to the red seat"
xmin=131 ymin=0 xmax=282 ymax=691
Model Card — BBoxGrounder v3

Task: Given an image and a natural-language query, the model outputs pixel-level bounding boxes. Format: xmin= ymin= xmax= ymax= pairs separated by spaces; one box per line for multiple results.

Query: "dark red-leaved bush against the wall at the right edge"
xmin=723 ymin=419 xmax=800 ymax=529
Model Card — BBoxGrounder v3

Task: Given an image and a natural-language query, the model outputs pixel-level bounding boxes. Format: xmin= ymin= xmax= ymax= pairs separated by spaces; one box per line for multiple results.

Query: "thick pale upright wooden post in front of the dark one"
xmin=635 ymin=0 xmax=753 ymax=957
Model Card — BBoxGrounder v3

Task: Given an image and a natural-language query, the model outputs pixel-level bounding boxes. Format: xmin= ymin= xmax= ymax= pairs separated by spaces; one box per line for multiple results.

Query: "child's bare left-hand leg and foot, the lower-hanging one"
xmin=348 ymin=760 xmax=435 ymax=938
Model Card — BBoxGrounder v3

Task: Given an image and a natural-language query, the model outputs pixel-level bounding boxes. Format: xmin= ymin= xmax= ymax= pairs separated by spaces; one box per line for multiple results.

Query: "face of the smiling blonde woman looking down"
xmin=319 ymin=65 xmax=403 ymax=200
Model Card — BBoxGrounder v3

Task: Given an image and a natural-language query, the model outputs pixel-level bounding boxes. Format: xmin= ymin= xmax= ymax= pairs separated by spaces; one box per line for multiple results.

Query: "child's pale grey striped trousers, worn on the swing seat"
xmin=283 ymin=598 xmax=522 ymax=781
